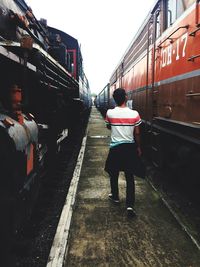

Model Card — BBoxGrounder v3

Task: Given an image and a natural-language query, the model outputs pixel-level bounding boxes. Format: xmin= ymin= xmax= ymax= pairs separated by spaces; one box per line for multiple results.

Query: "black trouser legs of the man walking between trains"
xmin=109 ymin=171 xmax=135 ymax=207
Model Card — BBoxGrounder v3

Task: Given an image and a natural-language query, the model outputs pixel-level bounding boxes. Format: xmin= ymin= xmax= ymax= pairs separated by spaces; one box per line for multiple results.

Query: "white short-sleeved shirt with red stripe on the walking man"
xmin=105 ymin=107 xmax=142 ymax=147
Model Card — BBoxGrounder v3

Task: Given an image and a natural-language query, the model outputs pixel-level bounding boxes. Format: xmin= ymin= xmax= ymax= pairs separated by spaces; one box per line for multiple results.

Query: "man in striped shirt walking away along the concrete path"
xmin=105 ymin=88 xmax=145 ymax=217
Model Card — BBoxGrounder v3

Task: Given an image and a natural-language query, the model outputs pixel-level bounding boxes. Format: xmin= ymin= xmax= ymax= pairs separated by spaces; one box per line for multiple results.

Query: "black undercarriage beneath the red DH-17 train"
xmin=142 ymin=117 xmax=200 ymax=201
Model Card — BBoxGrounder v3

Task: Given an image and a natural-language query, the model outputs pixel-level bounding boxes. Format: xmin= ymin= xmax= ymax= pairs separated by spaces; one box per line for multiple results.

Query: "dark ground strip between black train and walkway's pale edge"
xmin=13 ymin=123 xmax=88 ymax=267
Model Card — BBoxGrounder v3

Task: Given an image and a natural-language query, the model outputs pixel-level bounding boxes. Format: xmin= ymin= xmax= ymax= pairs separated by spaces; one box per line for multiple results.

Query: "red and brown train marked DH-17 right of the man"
xmin=98 ymin=0 xmax=200 ymax=185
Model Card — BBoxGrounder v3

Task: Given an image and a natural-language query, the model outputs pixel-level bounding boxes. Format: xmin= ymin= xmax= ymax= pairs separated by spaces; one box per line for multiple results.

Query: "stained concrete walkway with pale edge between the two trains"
xmin=47 ymin=107 xmax=200 ymax=267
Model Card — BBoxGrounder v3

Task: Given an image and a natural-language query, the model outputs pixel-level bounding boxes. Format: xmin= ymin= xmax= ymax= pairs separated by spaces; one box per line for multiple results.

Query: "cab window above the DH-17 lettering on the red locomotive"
xmin=167 ymin=0 xmax=195 ymax=27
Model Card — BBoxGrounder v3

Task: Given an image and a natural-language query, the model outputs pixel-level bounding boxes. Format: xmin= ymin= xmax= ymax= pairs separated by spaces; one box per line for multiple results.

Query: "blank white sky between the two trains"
xmin=26 ymin=0 xmax=155 ymax=93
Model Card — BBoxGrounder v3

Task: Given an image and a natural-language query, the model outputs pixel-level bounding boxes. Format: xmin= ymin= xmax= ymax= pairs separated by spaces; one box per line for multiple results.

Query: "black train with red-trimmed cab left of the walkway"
xmin=0 ymin=0 xmax=91 ymax=243
